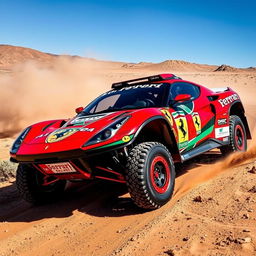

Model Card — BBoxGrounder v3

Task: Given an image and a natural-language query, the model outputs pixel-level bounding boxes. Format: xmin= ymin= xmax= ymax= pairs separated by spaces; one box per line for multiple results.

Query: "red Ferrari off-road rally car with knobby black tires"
xmin=10 ymin=74 xmax=251 ymax=209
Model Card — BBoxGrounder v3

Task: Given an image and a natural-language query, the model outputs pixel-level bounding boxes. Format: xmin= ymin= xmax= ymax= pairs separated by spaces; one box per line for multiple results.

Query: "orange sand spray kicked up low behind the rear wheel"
xmin=175 ymin=129 xmax=256 ymax=198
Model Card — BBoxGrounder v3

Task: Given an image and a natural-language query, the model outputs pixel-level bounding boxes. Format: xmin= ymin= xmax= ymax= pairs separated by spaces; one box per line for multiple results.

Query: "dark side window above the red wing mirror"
xmin=170 ymin=82 xmax=200 ymax=100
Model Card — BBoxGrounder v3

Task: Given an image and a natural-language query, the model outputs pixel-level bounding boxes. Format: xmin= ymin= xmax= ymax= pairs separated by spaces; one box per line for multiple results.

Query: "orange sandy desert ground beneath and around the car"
xmin=0 ymin=61 xmax=256 ymax=256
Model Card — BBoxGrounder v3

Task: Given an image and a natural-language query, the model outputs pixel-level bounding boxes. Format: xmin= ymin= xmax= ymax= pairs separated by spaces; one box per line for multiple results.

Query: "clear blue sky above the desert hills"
xmin=0 ymin=0 xmax=256 ymax=67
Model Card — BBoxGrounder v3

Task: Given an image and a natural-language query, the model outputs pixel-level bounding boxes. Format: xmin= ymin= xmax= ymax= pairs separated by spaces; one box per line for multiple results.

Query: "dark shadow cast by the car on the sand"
xmin=0 ymin=152 xmax=222 ymax=222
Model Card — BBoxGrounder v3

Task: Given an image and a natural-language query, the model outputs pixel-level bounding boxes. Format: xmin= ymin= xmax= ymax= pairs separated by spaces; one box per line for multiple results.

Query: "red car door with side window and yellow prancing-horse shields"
xmin=169 ymin=82 xmax=213 ymax=153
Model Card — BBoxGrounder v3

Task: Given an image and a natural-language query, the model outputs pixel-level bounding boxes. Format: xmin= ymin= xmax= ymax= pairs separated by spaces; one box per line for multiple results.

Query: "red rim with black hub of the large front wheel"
xmin=150 ymin=156 xmax=171 ymax=194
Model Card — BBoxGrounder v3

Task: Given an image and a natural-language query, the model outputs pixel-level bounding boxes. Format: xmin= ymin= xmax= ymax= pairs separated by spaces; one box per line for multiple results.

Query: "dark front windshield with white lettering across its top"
xmin=83 ymin=83 xmax=166 ymax=114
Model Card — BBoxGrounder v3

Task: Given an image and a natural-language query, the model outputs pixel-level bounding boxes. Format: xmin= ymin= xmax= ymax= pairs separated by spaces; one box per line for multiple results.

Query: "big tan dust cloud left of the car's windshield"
xmin=0 ymin=57 xmax=110 ymax=138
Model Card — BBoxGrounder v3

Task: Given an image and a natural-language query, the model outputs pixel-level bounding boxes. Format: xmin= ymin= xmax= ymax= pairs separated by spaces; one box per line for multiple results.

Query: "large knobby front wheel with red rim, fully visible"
xmin=126 ymin=142 xmax=175 ymax=209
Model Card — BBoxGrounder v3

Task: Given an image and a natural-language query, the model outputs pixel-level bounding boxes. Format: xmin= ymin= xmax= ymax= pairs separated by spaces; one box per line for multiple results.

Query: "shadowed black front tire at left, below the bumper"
xmin=16 ymin=164 xmax=66 ymax=205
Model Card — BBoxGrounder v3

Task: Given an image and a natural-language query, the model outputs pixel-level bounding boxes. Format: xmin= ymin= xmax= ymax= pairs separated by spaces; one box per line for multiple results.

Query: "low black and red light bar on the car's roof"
xmin=112 ymin=74 xmax=181 ymax=89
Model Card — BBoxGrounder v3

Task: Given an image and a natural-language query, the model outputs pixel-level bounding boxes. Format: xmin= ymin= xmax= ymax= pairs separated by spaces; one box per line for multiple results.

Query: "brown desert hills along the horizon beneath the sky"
xmin=0 ymin=44 xmax=256 ymax=72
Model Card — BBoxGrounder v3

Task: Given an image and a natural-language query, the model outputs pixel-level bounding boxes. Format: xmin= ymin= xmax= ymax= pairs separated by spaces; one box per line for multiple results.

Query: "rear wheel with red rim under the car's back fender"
xmin=220 ymin=115 xmax=247 ymax=155
